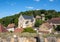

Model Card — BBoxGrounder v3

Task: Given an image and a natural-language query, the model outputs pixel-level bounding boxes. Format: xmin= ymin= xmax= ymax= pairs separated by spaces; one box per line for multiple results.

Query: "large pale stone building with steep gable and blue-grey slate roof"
xmin=18 ymin=15 xmax=35 ymax=28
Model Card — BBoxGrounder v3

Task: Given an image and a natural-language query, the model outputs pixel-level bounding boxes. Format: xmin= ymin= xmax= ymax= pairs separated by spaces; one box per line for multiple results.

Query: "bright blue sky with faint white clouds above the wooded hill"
xmin=0 ymin=0 xmax=60 ymax=18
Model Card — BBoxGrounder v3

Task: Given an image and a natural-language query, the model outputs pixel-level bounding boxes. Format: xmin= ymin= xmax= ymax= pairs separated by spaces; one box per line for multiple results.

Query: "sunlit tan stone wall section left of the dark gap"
xmin=0 ymin=37 xmax=36 ymax=42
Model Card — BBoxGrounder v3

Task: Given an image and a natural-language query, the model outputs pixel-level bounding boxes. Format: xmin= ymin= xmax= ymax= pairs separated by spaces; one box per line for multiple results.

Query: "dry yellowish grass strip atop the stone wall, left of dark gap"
xmin=0 ymin=32 xmax=37 ymax=38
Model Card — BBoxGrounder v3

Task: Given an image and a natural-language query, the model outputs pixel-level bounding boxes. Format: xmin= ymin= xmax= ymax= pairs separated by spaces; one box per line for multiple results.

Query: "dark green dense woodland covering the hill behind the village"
xmin=0 ymin=10 xmax=60 ymax=26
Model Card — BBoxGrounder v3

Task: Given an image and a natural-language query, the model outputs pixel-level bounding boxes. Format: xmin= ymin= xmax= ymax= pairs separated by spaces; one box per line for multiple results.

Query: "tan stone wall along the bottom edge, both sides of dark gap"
xmin=0 ymin=37 xmax=60 ymax=42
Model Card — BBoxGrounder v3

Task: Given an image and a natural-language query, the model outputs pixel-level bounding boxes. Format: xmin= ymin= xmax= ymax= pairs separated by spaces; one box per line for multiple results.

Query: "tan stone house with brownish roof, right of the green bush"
xmin=39 ymin=23 xmax=53 ymax=34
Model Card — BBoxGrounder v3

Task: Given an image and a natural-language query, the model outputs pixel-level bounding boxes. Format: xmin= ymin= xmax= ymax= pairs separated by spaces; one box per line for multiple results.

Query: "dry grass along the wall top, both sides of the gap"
xmin=0 ymin=32 xmax=60 ymax=38
